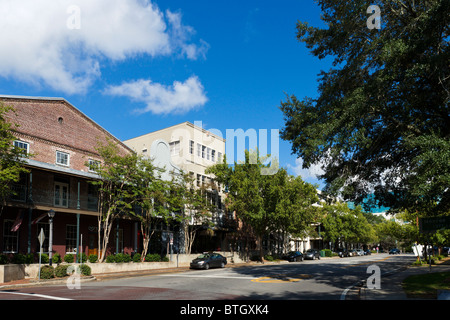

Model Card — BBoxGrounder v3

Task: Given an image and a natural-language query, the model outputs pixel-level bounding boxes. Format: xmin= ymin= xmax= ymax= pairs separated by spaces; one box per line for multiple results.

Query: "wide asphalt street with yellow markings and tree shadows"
xmin=0 ymin=254 xmax=415 ymax=301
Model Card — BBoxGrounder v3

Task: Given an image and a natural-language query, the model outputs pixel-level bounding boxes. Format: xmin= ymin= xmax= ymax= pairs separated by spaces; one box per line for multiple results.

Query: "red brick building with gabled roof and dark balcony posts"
xmin=0 ymin=96 xmax=138 ymax=256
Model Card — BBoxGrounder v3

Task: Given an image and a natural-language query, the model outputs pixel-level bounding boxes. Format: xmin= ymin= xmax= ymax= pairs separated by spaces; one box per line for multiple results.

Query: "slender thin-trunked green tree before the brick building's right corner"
xmin=91 ymin=141 xmax=164 ymax=262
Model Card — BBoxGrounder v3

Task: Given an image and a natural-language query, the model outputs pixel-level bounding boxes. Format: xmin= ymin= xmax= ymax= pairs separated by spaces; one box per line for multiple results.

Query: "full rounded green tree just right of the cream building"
xmin=205 ymin=150 xmax=320 ymax=260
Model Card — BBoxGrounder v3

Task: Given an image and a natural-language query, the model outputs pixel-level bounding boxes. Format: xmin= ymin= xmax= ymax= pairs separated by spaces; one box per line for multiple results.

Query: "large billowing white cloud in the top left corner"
xmin=0 ymin=0 xmax=208 ymax=94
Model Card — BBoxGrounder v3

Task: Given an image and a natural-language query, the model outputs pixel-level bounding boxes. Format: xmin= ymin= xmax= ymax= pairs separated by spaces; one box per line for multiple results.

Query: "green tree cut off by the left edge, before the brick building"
xmin=0 ymin=103 xmax=28 ymax=208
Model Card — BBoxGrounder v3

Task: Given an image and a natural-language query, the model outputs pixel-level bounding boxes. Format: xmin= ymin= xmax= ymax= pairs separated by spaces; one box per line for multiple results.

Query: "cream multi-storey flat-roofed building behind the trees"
xmin=124 ymin=122 xmax=227 ymax=251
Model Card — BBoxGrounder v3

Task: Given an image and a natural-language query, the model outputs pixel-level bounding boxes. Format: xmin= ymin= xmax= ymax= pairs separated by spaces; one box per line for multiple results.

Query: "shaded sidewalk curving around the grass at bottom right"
xmin=357 ymin=260 xmax=450 ymax=300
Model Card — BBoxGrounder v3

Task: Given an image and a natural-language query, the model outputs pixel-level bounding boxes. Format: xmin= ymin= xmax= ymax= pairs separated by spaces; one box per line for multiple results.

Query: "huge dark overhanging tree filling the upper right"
xmin=280 ymin=0 xmax=450 ymax=215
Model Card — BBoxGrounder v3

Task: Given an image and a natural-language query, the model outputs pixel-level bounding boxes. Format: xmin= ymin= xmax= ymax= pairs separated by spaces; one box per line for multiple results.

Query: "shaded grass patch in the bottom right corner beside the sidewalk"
xmin=402 ymin=272 xmax=450 ymax=299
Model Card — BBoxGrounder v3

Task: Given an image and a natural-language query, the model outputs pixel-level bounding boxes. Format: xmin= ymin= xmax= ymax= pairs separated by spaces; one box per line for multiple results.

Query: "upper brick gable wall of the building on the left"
xmin=0 ymin=97 xmax=130 ymax=171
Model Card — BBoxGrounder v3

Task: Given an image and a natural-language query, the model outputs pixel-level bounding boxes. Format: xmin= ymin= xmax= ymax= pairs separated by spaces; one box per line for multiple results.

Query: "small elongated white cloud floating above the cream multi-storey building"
xmin=105 ymin=76 xmax=208 ymax=114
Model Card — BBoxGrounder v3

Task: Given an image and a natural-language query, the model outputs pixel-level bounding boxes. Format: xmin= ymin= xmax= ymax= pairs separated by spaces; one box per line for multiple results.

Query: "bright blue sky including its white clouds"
xmin=0 ymin=0 xmax=330 ymax=189
